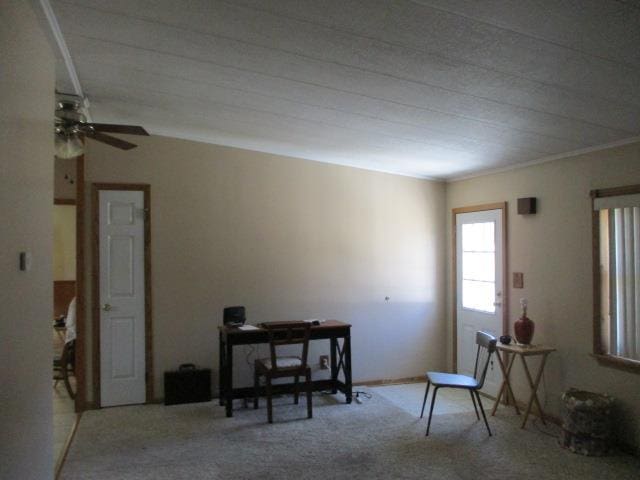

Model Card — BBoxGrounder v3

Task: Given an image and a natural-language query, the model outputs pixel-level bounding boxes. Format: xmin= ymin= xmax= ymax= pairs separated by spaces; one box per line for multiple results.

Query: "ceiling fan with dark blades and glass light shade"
xmin=55 ymin=93 xmax=149 ymax=158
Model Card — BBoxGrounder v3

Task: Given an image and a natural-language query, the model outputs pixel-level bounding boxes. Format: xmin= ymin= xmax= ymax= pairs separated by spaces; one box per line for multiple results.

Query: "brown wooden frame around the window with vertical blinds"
xmin=590 ymin=185 xmax=640 ymax=373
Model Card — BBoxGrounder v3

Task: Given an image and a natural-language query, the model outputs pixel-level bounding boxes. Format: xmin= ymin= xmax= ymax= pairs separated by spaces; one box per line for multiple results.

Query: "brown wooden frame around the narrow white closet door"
xmin=91 ymin=183 xmax=153 ymax=408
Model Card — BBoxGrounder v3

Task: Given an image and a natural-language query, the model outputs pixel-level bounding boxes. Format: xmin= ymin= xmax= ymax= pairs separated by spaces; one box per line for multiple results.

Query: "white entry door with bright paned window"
xmin=456 ymin=210 xmax=504 ymax=395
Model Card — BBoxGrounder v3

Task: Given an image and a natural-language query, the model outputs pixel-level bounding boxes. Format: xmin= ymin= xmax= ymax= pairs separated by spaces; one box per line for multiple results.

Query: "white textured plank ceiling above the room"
xmin=51 ymin=0 xmax=640 ymax=179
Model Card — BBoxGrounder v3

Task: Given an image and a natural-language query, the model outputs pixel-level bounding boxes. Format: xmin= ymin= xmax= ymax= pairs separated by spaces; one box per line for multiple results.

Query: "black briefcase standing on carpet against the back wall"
xmin=164 ymin=363 xmax=211 ymax=405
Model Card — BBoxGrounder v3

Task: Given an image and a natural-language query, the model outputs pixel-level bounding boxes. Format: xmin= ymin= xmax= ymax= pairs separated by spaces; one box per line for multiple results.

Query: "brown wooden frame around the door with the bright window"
xmin=451 ymin=202 xmax=509 ymax=372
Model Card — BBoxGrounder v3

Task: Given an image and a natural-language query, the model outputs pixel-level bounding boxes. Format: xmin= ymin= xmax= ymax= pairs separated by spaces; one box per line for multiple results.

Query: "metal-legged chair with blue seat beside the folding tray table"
xmin=420 ymin=332 xmax=496 ymax=436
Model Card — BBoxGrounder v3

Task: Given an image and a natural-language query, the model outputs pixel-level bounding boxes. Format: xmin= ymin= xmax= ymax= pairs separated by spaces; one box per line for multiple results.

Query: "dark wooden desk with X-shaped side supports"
xmin=218 ymin=320 xmax=352 ymax=417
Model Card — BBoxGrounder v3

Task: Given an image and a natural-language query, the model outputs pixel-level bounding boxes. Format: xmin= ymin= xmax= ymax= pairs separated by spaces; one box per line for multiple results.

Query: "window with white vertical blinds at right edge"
xmin=592 ymin=186 xmax=640 ymax=365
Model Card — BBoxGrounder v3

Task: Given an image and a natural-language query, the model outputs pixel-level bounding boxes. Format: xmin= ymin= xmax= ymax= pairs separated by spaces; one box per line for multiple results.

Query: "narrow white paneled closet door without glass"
xmin=98 ymin=190 xmax=146 ymax=407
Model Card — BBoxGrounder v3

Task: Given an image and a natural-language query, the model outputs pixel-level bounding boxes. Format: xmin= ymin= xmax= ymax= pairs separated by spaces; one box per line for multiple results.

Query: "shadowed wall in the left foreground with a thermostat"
xmin=0 ymin=0 xmax=54 ymax=480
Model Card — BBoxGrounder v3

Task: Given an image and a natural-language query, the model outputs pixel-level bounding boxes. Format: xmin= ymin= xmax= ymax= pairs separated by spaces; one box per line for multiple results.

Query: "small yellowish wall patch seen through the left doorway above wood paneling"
xmin=53 ymin=205 xmax=76 ymax=281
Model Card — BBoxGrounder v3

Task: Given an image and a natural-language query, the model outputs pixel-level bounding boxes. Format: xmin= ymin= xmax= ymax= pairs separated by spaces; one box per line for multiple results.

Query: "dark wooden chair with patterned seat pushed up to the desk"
xmin=253 ymin=321 xmax=313 ymax=423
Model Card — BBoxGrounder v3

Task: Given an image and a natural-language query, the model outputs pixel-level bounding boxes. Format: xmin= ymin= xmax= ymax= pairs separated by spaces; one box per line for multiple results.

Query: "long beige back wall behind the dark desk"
xmin=86 ymin=136 xmax=445 ymax=402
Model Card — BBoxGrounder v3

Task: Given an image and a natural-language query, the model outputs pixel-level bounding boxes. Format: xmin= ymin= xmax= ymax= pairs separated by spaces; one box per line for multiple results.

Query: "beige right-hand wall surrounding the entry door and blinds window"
xmin=447 ymin=143 xmax=640 ymax=446
